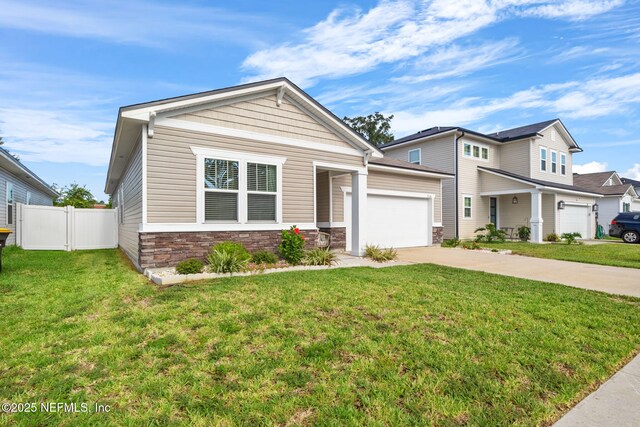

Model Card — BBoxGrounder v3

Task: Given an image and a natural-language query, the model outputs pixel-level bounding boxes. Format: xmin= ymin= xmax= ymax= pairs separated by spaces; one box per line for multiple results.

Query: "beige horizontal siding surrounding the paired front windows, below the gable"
xmin=147 ymin=126 xmax=362 ymax=223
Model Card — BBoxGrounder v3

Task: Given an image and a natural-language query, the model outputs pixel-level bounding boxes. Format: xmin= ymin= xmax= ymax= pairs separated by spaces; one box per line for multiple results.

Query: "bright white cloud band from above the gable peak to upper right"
xmin=242 ymin=0 xmax=620 ymax=86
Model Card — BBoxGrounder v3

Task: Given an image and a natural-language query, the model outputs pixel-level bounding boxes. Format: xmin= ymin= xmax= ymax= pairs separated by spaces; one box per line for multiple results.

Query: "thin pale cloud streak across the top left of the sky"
xmin=0 ymin=0 xmax=276 ymax=48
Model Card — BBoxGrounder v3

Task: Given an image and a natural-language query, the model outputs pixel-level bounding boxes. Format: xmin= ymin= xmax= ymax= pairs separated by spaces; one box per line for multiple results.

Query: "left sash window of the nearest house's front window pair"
xmin=204 ymin=159 xmax=239 ymax=221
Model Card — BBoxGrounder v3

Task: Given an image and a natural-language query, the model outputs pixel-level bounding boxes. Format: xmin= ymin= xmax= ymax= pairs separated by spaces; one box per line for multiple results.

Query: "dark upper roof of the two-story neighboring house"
xmin=380 ymin=119 xmax=582 ymax=151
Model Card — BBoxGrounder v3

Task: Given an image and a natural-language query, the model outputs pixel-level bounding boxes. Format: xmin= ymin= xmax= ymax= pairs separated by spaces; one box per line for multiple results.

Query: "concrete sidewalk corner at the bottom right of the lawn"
xmin=554 ymin=355 xmax=640 ymax=427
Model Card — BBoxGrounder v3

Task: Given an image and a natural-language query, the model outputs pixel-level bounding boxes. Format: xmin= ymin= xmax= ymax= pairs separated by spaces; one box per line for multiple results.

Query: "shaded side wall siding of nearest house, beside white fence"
xmin=113 ymin=140 xmax=142 ymax=267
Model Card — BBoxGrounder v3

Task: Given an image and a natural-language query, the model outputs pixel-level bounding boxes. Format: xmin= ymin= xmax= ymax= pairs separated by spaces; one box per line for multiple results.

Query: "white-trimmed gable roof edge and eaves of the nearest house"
xmin=105 ymin=77 xmax=383 ymax=194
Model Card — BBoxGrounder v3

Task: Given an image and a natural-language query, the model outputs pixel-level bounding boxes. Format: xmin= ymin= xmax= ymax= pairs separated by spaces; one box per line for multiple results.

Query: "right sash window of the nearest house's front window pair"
xmin=247 ymin=163 xmax=278 ymax=221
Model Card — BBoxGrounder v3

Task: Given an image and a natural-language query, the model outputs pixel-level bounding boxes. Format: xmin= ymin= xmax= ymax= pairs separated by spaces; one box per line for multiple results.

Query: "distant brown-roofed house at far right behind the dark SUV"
xmin=573 ymin=171 xmax=640 ymax=232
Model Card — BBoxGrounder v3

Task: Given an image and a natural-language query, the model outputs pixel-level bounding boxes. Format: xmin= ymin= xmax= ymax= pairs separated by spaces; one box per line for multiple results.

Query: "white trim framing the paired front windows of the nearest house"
xmin=190 ymin=146 xmax=287 ymax=226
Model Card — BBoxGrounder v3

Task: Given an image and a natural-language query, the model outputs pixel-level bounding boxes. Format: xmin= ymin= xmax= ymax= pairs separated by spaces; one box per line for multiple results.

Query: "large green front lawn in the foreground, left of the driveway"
xmin=0 ymin=248 xmax=640 ymax=426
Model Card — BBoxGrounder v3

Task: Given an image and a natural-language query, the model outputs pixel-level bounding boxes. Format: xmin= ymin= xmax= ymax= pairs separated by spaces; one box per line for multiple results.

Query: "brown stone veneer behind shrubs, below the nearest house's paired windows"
xmin=138 ymin=230 xmax=318 ymax=270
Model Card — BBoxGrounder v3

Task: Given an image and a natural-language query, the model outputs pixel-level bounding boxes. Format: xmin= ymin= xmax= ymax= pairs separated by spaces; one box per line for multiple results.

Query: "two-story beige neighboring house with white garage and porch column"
xmin=381 ymin=119 xmax=601 ymax=242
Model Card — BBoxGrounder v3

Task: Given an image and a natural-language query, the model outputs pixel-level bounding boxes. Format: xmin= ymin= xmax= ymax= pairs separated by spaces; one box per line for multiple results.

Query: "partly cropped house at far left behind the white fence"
xmin=0 ymin=148 xmax=58 ymax=245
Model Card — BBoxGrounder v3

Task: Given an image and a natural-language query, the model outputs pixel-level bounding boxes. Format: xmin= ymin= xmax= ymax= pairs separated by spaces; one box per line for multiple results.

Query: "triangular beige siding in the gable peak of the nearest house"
xmin=173 ymin=93 xmax=351 ymax=147
